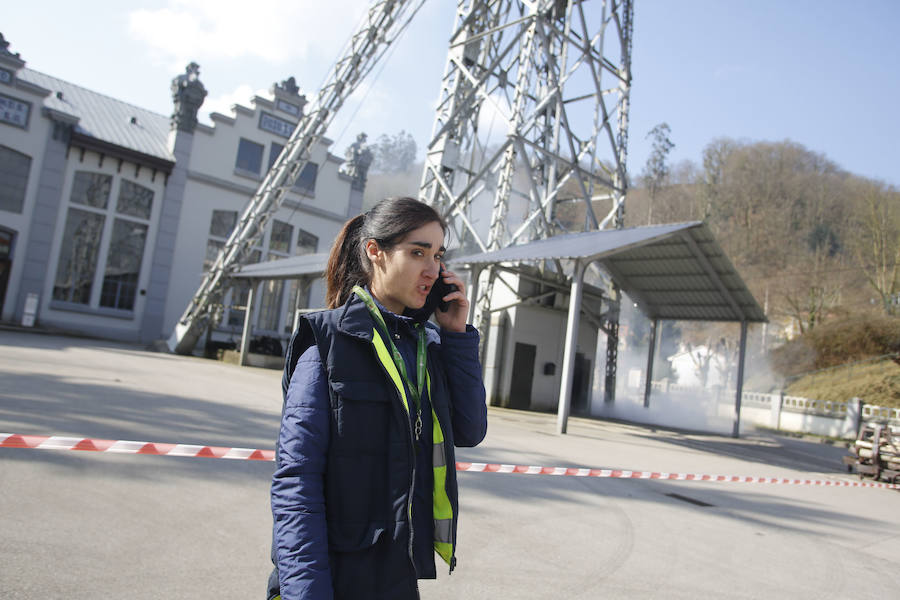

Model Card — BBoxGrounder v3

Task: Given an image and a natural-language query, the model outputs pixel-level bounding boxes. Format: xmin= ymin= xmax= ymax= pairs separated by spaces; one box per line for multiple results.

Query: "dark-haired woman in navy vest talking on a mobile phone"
xmin=270 ymin=198 xmax=487 ymax=600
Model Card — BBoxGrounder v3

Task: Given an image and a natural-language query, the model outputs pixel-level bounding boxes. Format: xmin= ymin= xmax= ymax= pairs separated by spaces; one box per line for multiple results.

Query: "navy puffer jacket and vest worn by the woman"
xmin=270 ymin=295 xmax=487 ymax=600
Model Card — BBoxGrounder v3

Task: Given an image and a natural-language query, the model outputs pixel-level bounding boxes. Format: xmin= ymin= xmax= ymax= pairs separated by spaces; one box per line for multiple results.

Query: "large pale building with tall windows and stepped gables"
xmin=0 ymin=35 xmax=366 ymax=350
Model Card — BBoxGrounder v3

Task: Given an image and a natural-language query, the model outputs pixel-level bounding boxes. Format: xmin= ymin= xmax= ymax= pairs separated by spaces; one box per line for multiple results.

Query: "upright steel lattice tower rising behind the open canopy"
xmin=420 ymin=0 xmax=633 ymax=401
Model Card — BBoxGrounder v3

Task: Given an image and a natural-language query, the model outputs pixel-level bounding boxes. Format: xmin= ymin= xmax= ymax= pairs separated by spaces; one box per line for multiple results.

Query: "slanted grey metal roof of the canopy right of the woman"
xmin=453 ymin=221 xmax=766 ymax=322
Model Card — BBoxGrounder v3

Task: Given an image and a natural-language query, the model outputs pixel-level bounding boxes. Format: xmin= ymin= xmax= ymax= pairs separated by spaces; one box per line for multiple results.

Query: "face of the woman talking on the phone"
xmin=366 ymin=221 xmax=445 ymax=314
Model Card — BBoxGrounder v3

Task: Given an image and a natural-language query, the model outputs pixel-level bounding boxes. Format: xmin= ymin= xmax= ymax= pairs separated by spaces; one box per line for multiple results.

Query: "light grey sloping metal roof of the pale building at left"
xmin=16 ymin=68 xmax=175 ymax=162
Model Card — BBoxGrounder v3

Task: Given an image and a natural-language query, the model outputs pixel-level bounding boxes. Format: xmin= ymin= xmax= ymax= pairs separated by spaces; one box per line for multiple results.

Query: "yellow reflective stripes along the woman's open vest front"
xmin=372 ymin=329 xmax=453 ymax=565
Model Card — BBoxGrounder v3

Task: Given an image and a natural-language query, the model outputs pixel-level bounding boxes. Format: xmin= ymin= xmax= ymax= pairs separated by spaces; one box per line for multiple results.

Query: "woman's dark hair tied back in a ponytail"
xmin=325 ymin=197 xmax=447 ymax=308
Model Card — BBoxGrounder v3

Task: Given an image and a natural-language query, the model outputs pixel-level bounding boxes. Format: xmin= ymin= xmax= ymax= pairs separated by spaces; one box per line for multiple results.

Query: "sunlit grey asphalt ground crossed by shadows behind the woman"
xmin=0 ymin=331 xmax=900 ymax=600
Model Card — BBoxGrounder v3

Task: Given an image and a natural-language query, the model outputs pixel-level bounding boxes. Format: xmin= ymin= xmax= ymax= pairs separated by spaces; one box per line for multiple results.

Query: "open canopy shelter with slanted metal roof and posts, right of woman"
xmin=453 ymin=222 xmax=766 ymax=437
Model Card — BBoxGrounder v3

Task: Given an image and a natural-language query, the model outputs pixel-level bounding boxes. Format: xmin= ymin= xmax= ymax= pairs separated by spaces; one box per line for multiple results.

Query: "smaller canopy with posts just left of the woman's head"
xmin=229 ymin=254 xmax=328 ymax=365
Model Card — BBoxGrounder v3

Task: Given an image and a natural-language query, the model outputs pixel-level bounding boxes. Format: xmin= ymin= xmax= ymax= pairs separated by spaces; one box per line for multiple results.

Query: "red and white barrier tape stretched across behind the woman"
xmin=0 ymin=433 xmax=900 ymax=489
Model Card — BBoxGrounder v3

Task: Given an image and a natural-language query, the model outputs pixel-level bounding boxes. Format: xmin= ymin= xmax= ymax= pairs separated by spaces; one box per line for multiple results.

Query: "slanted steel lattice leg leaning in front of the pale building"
xmin=169 ymin=0 xmax=424 ymax=354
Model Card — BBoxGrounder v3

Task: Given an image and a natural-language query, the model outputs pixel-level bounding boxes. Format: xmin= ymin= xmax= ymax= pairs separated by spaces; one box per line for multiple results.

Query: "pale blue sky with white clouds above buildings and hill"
xmin=7 ymin=0 xmax=900 ymax=186
